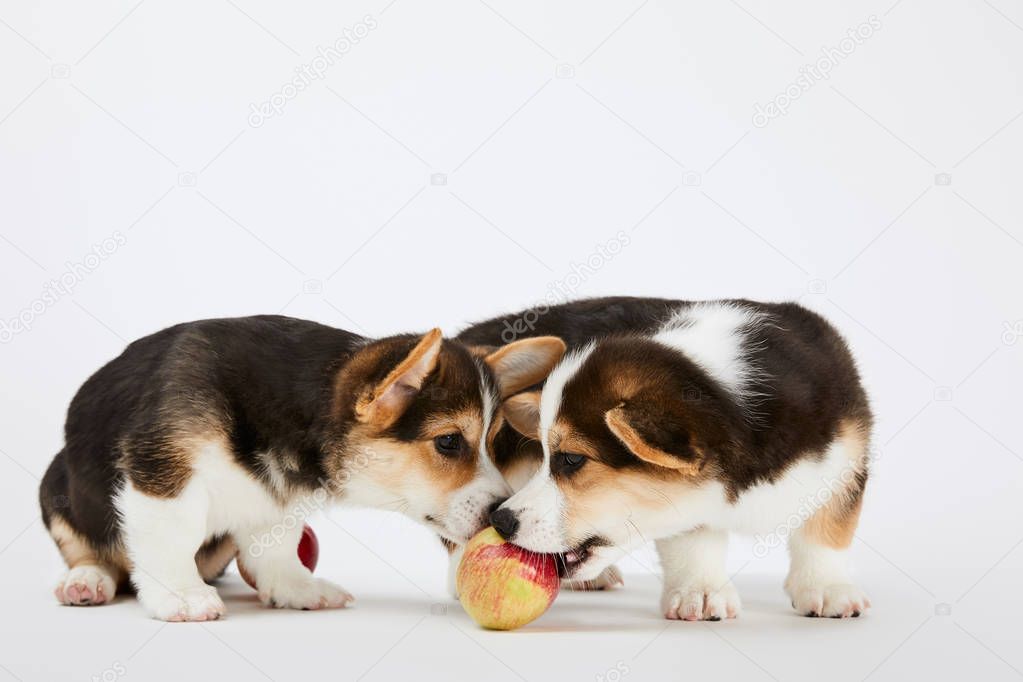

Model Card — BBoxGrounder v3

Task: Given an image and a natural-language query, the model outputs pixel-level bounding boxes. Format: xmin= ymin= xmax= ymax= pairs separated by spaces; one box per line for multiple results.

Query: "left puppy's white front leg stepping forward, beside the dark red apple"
xmin=235 ymin=518 xmax=354 ymax=609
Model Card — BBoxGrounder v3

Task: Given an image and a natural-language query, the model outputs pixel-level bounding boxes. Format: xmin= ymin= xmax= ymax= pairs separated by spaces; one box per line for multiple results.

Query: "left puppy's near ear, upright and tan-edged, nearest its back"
xmin=355 ymin=329 xmax=444 ymax=427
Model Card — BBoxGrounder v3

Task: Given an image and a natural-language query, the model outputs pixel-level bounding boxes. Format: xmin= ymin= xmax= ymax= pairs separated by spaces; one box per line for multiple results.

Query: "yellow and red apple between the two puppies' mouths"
xmin=455 ymin=528 xmax=562 ymax=630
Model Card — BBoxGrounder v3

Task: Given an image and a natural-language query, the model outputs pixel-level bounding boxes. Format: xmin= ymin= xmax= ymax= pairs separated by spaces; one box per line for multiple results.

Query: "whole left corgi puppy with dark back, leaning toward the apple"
xmin=40 ymin=316 xmax=565 ymax=621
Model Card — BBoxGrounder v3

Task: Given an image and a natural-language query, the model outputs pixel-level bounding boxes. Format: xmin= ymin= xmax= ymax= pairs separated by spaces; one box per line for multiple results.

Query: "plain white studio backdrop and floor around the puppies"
xmin=0 ymin=0 xmax=1023 ymax=681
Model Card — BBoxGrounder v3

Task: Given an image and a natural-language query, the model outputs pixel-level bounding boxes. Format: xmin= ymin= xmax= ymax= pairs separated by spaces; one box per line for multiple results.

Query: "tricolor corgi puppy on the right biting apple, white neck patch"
xmin=491 ymin=299 xmax=872 ymax=621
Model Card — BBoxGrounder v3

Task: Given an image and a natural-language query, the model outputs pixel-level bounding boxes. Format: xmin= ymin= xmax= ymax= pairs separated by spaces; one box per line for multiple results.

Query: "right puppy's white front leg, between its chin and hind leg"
xmin=657 ymin=528 xmax=742 ymax=621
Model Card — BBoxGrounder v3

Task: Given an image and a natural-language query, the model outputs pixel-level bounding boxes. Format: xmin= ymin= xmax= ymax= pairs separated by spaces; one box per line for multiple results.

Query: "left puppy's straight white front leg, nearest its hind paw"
xmin=117 ymin=480 xmax=224 ymax=621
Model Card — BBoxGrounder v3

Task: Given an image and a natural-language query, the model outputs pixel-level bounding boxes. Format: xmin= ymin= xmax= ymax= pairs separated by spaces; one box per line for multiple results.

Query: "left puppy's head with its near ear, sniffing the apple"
xmin=341 ymin=333 xmax=504 ymax=542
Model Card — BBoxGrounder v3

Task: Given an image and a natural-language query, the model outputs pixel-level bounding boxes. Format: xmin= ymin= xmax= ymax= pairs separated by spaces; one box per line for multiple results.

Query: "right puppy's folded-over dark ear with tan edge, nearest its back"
xmin=604 ymin=402 xmax=706 ymax=475
